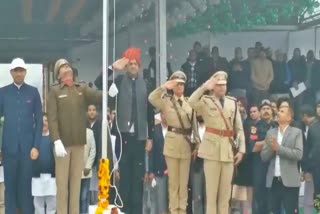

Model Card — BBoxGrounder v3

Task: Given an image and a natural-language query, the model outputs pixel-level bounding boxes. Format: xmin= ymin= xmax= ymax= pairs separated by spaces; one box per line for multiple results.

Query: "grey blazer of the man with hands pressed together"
xmin=261 ymin=126 xmax=303 ymax=188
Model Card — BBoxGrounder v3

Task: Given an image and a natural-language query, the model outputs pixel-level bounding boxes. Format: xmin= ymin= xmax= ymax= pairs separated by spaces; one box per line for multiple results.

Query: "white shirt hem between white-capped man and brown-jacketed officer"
xmin=31 ymin=174 xmax=57 ymax=196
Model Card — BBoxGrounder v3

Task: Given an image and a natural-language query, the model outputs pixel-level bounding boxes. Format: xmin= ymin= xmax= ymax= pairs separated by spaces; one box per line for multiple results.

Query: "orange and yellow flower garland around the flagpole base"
xmin=96 ymin=159 xmax=110 ymax=214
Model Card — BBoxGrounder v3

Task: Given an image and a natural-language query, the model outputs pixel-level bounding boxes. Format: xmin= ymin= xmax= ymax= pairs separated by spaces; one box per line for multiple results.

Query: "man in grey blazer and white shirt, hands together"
xmin=261 ymin=107 xmax=303 ymax=214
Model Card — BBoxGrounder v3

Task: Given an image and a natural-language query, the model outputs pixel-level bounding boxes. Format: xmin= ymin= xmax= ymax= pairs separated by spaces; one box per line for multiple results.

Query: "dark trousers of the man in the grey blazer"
xmin=270 ymin=177 xmax=299 ymax=214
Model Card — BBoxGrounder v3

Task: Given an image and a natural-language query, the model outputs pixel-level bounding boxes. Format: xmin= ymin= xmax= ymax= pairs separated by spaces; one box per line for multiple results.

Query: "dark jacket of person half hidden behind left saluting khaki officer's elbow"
xmin=151 ymin=124 xmax=167 ymax=176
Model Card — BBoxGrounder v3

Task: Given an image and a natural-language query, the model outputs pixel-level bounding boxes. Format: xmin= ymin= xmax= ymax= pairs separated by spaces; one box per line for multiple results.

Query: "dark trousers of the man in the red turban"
xmin=119 ymin=133 xmax=145 ymax=214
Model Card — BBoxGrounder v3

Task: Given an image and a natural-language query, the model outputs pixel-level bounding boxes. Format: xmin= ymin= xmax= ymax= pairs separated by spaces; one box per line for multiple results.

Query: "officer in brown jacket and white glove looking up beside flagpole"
xmin=48 ymin=59 xmax=102 ymax=214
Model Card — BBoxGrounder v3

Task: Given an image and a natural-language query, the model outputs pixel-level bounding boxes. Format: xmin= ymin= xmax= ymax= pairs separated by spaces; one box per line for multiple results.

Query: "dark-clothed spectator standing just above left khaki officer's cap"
xmin=181 ymin=50 xmax=201 ymax=97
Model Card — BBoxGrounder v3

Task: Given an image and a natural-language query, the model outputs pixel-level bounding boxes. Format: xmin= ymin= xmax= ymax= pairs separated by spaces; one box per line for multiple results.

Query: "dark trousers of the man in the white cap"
xmin=3 ymin=153 xmax=34 ymax=214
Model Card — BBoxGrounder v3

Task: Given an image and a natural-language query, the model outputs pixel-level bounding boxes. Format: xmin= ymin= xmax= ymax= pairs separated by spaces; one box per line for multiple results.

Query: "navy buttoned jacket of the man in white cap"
xmin=0 ymin=83 xmax=43 ymax=156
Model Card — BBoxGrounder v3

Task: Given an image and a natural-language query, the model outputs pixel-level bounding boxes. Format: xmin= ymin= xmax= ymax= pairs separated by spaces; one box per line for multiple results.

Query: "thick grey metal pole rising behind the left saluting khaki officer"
xmin=155 ymin=0 xmax=168 ymax=86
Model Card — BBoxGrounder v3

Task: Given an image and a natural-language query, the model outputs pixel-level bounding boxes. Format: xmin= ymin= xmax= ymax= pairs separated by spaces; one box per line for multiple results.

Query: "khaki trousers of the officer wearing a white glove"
xmin=55 ymin=145 xmax=84 ymax=214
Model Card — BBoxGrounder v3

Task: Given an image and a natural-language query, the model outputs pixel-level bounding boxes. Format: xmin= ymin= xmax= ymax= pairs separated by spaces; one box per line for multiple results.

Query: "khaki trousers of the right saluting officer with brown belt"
xmin=203 ymin=159 xmax=234 ymax=214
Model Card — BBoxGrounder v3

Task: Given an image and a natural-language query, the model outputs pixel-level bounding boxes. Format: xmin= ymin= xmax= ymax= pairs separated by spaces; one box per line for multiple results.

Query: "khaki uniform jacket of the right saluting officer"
xmin=188 ymin=86 xmax=246 ymax=162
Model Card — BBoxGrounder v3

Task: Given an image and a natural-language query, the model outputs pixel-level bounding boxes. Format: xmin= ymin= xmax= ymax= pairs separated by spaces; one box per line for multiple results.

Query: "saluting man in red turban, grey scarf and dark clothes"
xmin=95 ymin=48 xmax=154 ymax=214
